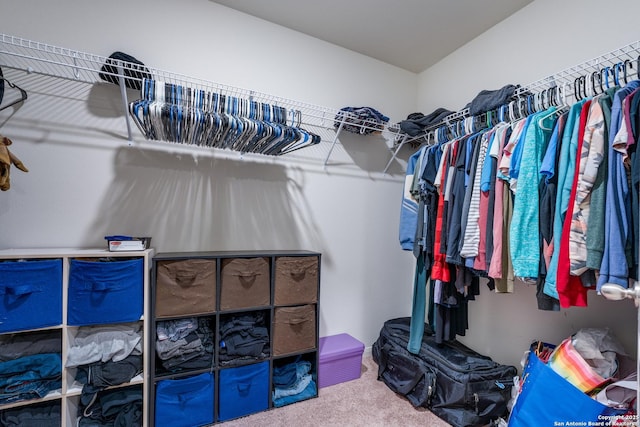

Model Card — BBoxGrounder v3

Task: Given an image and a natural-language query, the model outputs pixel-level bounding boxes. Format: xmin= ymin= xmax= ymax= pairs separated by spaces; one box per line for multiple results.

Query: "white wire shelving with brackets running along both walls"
xmin=5 ymin=34 xmax=640 ymax=173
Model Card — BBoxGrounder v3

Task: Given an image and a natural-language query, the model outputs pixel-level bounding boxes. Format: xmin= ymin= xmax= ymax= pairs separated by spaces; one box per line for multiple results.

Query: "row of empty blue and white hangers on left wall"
xmin=129 ymin=79 xmax=320 ymax=155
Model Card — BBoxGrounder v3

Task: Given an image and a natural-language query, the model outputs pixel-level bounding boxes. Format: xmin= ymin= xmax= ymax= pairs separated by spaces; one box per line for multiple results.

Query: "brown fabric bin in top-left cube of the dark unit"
xmin=156 ymin=258 xmax=216 ymax=317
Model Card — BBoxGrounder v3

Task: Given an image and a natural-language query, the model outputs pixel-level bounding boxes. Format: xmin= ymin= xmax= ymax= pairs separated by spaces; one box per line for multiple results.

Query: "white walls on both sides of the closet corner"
xmin=5 ymin=0 xmax=640 ymax=372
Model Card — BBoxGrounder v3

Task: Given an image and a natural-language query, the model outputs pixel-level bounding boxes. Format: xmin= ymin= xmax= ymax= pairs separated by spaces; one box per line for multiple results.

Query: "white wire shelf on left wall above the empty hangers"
xmin=0 ymin=34 xmax=402 ymax=173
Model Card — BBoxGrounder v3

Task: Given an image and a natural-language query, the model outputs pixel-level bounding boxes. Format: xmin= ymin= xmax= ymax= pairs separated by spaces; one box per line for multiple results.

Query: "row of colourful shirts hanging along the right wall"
xmin=402 ymin=69 xmax=640 ymax=342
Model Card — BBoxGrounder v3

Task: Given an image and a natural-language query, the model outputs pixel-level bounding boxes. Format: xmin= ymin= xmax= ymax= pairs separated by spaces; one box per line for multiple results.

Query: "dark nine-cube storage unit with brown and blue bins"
xmin=148 ymin=251 xmax=321 ymax=427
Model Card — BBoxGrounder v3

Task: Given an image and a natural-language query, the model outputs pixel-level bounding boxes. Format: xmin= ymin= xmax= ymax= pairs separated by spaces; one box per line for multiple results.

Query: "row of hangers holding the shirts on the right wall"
xmin=425 ymin=57 xmax=640 ymax=144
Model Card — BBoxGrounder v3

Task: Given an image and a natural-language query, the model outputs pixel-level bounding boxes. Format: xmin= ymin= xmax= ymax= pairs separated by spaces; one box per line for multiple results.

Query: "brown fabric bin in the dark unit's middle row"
xmin=273 ymin=305 xmax=316 ymax=356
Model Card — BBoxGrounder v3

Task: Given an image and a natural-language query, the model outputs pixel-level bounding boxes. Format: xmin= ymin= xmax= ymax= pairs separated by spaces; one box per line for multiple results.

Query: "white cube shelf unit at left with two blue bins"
xmin=0 ymin=249 xmax=154 ymax=427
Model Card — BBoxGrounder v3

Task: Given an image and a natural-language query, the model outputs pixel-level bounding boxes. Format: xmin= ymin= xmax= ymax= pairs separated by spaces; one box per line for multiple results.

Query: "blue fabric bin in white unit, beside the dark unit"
xmin=67 ymin=258 xmax=144 ymax=325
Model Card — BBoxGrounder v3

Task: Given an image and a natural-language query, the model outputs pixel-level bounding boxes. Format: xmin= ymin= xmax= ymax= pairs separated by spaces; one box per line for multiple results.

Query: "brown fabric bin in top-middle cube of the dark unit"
xmin=220 ymin=258 xmax=271 ymax=310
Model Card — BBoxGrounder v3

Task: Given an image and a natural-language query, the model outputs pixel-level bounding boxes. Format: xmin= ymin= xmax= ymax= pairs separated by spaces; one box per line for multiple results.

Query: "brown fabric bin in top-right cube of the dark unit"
xmin=274 ymin=256 xmax=318 ymax=305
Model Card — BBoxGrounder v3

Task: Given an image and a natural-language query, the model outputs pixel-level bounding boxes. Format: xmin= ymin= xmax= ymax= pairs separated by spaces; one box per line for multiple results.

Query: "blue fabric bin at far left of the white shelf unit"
xmin=0 ymin=259 xmax=62 ymax=332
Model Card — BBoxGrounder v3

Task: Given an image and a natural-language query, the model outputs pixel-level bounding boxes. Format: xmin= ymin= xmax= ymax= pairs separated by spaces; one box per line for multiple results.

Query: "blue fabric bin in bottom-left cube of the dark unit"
xmin=155 ymin=372 xmax=213 ymax=427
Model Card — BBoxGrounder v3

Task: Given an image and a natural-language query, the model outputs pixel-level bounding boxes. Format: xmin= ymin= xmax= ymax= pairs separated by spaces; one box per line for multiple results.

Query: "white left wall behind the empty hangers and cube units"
xmin=0 ymin=0 xmax=417 ymax=352
